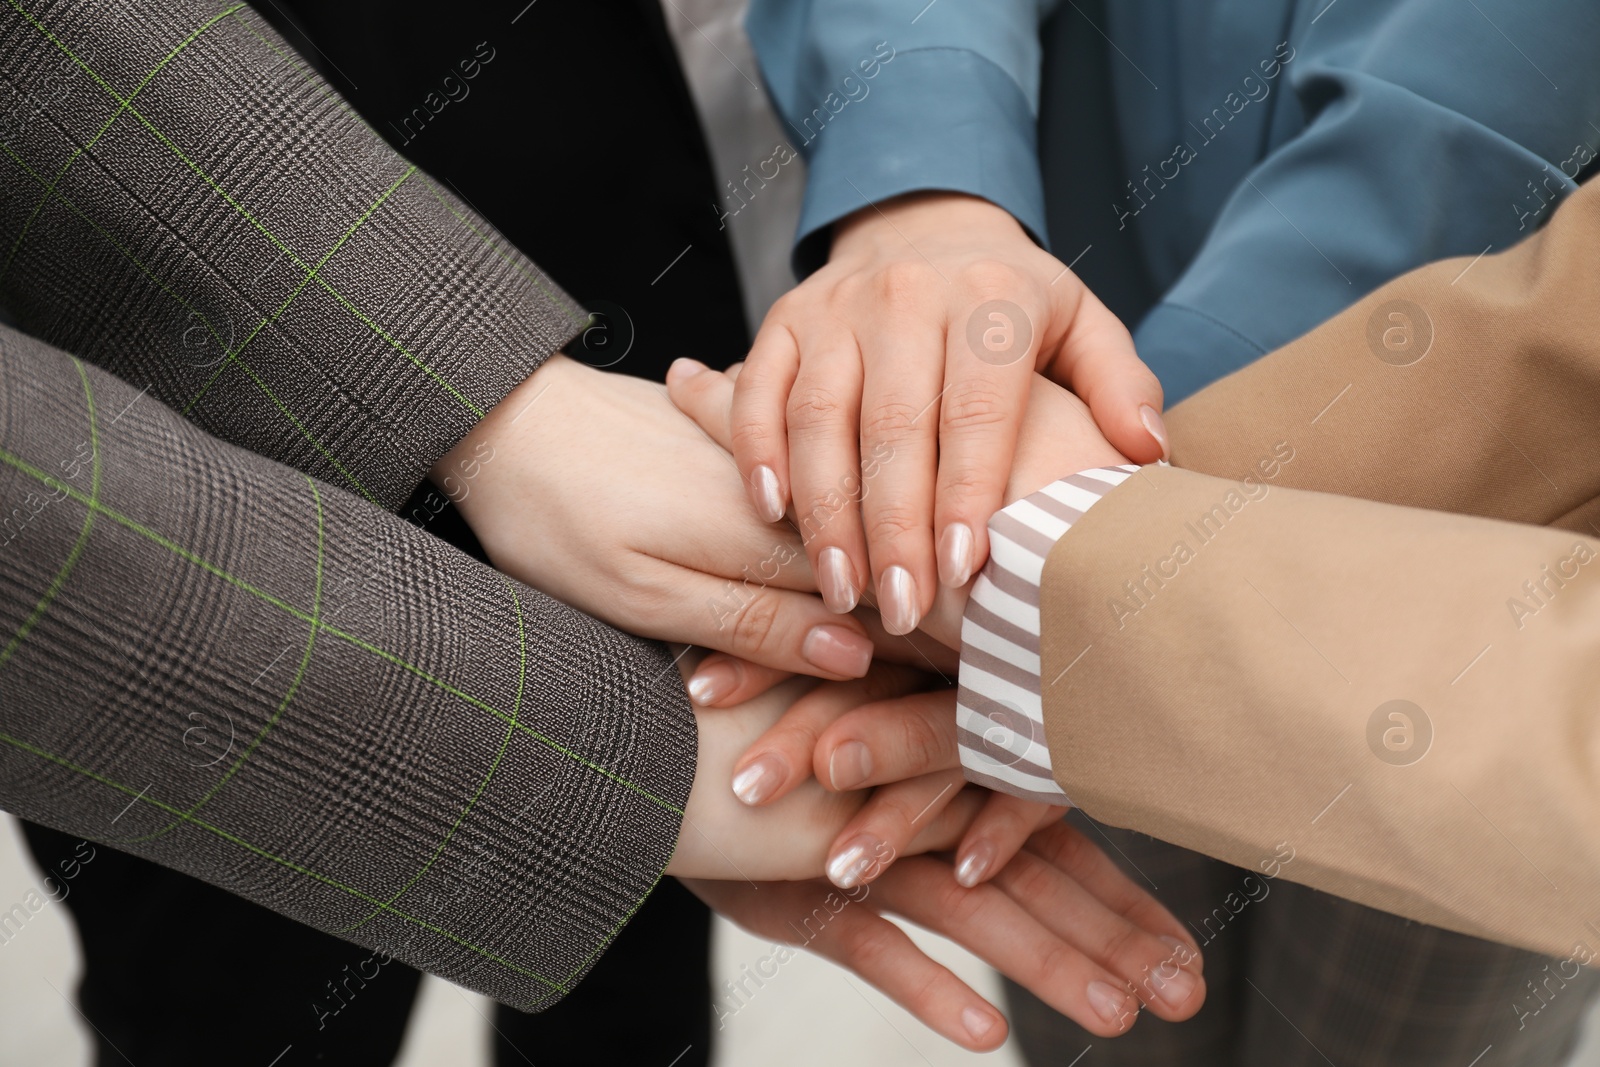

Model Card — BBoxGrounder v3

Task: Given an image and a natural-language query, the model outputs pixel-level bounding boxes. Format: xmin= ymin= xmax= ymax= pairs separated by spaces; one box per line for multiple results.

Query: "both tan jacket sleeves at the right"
xmin=1040 ymin=184 xmax=1600 ymax=955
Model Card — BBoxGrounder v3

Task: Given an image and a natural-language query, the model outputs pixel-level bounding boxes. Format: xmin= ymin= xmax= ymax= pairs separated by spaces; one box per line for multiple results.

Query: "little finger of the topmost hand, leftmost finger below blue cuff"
xmin=728 ymin=326 xmax=800 ymax=523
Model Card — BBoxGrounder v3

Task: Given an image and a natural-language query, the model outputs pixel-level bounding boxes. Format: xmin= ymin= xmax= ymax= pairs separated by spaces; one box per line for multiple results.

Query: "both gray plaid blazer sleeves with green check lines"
xmin=0 ymin=0 xmax=696 ymax=1009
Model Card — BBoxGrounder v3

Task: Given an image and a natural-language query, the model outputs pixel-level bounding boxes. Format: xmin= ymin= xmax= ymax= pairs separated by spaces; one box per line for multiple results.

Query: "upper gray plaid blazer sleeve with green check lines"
xmin=0 ymin=0 xmax=586 ymax=509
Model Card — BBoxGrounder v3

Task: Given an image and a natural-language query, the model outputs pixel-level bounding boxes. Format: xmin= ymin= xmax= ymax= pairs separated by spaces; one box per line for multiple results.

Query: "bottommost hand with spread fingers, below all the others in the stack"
xmin=685 ymin=822 xmax=1205 ymax=1051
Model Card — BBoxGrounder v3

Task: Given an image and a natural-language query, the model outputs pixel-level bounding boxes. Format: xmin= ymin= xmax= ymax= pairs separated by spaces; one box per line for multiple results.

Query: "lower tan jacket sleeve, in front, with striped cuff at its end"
xmin=1042 ymin=464 xmax=1600 ymax=953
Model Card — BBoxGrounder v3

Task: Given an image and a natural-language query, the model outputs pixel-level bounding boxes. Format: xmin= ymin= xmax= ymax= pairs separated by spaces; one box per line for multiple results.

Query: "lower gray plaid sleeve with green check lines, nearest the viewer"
xmin=0 ymin=328 xmax=696 ymax=1009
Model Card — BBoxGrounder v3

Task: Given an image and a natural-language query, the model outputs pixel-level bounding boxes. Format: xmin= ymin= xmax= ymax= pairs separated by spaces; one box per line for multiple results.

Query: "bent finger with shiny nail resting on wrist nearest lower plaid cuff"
xmin=733 ymin=664 xmax=925 ymax=806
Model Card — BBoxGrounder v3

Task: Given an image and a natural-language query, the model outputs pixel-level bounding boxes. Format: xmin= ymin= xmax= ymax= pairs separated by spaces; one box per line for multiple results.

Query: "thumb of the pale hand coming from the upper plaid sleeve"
xmin=649 ymin=566 xmax=872 ymax=680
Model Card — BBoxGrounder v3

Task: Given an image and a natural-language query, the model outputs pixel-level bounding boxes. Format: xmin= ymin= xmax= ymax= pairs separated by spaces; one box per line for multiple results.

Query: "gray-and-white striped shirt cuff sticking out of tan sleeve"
xmin=955 ymin=464 xmax=1139 ymax=805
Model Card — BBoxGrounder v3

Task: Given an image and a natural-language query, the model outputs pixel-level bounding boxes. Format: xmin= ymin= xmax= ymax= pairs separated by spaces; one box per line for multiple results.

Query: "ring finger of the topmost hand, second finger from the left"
xmin=780 ymin=330 xmax=870 ymax=613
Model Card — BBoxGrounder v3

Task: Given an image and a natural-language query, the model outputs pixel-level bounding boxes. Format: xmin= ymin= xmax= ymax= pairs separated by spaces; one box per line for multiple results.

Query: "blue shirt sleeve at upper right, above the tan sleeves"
xmin=1134 ymin=0 xmax=1600 ymax=403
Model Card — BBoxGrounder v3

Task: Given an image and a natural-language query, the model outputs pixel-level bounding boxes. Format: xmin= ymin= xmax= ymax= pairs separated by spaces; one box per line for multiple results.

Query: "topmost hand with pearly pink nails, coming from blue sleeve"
xmin=691 ymin=194 xmax=1165 ymax=633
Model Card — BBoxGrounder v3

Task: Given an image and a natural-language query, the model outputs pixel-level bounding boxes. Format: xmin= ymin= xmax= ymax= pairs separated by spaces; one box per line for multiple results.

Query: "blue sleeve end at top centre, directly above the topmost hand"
xmin=746 ymin=0 xmax=1056 ymax=277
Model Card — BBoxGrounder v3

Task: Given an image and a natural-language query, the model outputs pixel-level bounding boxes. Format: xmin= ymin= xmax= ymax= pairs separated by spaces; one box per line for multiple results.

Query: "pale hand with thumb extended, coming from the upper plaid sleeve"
xmin=432 ymin=355 xmax=872 ymax=678
